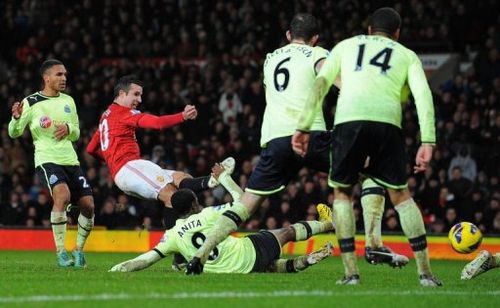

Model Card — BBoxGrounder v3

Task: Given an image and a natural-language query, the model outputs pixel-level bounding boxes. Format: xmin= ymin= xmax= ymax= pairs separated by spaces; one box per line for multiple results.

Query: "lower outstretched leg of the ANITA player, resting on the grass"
xmin=269 ymin=242 xmax=333 ymax=273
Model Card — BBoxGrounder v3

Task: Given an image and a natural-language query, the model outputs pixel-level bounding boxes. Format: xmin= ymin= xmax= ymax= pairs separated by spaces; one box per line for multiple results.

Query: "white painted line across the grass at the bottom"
xmin=0 ymin=289 xmax=500 ymax=304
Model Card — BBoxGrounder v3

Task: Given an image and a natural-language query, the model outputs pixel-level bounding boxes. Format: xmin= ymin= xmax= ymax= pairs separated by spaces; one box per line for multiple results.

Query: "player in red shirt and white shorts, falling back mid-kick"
xmin=87 ymin=75 xmax=234 ymax=207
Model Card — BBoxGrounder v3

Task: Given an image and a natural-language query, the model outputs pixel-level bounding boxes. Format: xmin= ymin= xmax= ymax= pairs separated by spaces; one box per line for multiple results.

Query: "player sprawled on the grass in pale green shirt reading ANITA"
xmin=110 ymin=165 xmax=333 ymax=273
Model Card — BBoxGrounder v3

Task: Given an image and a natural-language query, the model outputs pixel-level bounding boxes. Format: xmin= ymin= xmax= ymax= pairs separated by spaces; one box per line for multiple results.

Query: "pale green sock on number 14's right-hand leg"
xmin=395 ymin=198 xmax=432 ymax=275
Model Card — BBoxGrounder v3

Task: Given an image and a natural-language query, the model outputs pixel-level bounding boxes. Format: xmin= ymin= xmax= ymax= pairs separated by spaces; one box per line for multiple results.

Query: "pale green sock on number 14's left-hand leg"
xmin=333 ymin=200 xmax=359 ymax=277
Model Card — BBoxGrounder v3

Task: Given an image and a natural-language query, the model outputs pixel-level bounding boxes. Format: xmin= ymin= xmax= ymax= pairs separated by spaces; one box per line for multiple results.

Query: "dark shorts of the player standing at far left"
xmin=36 ymin=163 xmax=92 ymax=202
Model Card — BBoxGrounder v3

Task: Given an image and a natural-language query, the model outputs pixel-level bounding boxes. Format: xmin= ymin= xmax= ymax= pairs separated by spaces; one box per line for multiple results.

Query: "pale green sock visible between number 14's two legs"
xmin=361 ymin=179 xmax=385 ymax=248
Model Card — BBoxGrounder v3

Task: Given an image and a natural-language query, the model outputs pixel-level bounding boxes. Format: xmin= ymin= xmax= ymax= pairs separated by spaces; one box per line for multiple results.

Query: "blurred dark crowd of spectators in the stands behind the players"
xmin=0 ymin=0 xmax=500 ymax=234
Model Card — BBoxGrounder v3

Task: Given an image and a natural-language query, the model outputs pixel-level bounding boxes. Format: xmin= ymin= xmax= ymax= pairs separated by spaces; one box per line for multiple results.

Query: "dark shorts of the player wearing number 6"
xmin=246 ymin=131 xmax=332 ymax=195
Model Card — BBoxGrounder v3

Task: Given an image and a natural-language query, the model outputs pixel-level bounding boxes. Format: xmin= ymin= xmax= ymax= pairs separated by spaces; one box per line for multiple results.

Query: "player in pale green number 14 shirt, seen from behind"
xmin=292 ymin=8 xmax=441 ymax=286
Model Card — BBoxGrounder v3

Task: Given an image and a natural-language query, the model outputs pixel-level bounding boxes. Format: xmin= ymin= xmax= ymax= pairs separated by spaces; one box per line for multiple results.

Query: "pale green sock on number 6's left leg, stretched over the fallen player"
xmin=194 ymin=201 xmax=250 ymax=263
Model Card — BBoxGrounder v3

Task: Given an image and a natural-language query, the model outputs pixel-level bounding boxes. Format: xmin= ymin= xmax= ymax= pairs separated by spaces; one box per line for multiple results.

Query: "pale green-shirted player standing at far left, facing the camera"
xmin=9 ymin=60 xmax=94 ymax=268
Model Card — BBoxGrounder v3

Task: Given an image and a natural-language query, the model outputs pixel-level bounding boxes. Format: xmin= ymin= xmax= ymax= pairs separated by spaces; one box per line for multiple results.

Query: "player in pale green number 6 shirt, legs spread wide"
xmin=187 ymin=13 xmax=408 ymax=274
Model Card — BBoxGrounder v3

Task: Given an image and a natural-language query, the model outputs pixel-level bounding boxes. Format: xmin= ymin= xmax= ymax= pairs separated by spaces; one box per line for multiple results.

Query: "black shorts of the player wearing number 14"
xmin=329 ymin=121 xmax=408 ymax=189
